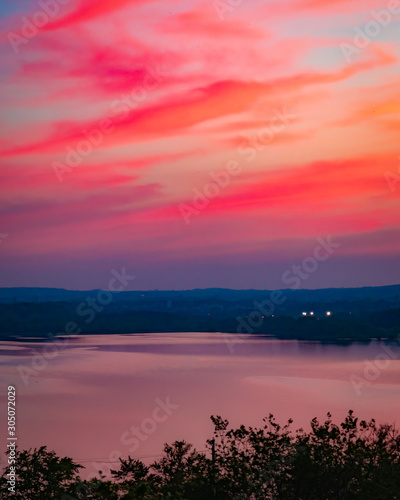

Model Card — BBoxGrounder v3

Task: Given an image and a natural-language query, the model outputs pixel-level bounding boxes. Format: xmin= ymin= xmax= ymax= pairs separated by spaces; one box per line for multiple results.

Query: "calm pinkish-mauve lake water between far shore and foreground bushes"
xmin=0 ymin=333 xmax=400 ymax=477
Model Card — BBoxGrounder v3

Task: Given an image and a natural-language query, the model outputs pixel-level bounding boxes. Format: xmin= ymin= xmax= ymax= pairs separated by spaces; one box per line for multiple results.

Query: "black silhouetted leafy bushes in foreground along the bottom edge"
xmin=0 ymin=411 xmax=400 ymax=500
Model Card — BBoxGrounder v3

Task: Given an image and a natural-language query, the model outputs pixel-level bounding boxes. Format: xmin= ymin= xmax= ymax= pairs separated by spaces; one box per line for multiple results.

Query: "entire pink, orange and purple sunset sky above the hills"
xmin=0 ymin=0 xmax=400 ymax=290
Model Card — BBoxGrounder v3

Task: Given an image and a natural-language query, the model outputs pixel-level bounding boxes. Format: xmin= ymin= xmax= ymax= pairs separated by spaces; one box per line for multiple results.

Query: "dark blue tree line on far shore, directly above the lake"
xmin=0 ymin=302 xmax=400 ymax=342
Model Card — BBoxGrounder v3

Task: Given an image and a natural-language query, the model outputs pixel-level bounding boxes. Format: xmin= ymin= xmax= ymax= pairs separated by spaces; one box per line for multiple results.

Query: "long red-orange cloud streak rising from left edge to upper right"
xmin=0 ymin=44 xmax=397 ymax=157
